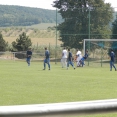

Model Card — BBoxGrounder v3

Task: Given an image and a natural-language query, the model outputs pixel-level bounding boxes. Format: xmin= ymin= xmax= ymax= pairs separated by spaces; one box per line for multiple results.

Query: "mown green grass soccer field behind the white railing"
xmin=0 ymin=60 xmax=117 ymax=117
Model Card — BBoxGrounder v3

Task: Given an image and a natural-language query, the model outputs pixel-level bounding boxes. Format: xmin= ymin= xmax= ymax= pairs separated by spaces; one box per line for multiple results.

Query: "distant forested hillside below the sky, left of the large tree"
xmin=0 ymin=5 xmax=62 ymax=27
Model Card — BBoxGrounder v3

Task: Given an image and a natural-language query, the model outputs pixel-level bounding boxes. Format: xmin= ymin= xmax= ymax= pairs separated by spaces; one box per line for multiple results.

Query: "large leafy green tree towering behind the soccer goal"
xmin=53 ymin=0 xmax=116 ymax=48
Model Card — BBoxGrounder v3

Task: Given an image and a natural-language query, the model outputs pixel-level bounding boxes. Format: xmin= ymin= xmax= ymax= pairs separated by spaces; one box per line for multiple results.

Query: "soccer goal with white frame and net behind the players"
xmin=83 ymin=39 xmax=117 ymax=67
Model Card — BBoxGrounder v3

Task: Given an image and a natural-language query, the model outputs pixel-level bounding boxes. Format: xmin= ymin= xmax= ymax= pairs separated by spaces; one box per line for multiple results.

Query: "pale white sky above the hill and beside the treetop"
xmin=0 ymin=0 xmax=117 ymax=10
